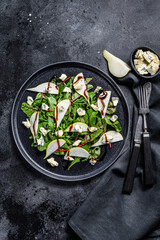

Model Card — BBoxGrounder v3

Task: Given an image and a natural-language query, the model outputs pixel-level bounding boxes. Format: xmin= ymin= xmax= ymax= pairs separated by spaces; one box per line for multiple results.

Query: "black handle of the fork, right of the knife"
xmin=143 ymin=132 xmax=154 ymax=187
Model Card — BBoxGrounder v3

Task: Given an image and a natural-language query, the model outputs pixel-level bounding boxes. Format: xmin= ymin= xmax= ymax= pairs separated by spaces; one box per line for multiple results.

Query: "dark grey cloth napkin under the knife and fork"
xmin=69 ymin=73 xmax=160 ymax=240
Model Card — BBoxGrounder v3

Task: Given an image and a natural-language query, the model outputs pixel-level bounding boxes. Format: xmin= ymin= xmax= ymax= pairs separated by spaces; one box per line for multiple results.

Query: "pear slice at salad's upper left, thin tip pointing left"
xmin=27 ymin=82 xmax=59 ymax=94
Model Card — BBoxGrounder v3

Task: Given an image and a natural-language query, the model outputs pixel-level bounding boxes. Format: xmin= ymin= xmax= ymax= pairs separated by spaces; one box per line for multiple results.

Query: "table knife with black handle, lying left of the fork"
xmin=122 ymin=115 xmax=143 ymax=194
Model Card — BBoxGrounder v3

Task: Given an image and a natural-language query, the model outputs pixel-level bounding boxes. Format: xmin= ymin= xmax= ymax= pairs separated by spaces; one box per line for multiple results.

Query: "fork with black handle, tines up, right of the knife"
xmin=138 ymin=82 xmax=154 ymax=187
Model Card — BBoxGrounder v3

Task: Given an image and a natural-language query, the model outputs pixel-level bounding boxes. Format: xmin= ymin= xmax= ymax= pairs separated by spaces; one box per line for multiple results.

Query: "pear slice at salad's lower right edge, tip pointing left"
xmin=92 ymin=131 xmax=123 ymax=147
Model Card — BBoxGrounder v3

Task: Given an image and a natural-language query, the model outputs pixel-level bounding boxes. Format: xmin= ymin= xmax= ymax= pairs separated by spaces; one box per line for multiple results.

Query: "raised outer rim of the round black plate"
xmin=11 ymin=61 xmax=130 ymax=182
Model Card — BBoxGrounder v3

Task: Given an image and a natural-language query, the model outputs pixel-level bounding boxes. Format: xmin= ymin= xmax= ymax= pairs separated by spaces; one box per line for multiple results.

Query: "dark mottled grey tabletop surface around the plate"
xmin=0 ymin=0 xmax=160 ymax=240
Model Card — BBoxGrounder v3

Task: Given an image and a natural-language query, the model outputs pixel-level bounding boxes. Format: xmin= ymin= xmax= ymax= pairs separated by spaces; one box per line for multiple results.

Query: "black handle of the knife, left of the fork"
xmin=122 ymin=143 xmax=140 ymax=194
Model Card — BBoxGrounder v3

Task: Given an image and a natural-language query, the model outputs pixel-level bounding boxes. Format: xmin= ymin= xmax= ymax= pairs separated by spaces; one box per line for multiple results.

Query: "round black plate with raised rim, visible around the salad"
xmin=11 ymin=62 xmax=129 ymax=181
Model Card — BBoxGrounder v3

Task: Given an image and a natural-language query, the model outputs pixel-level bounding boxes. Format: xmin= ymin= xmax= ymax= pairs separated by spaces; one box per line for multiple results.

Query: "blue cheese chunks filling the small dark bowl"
xmin=134 ymin=49 xmax=160 ymax=75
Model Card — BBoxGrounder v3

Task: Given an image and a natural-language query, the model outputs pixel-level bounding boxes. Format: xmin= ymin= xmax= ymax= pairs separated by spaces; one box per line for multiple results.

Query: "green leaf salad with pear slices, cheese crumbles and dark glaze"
xmin=21 ymin=72 xmax=123 ymax=170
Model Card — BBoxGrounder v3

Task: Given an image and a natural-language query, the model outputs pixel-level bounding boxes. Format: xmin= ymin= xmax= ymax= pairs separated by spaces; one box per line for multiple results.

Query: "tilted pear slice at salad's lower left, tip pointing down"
xmin=44 ymin=139 xmax=66 ymax=159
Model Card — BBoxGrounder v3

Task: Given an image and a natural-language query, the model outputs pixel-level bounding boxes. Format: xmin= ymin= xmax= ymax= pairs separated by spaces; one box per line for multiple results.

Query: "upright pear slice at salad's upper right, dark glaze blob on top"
xmin=97 ymin=91 xmax=111 ymax=118
